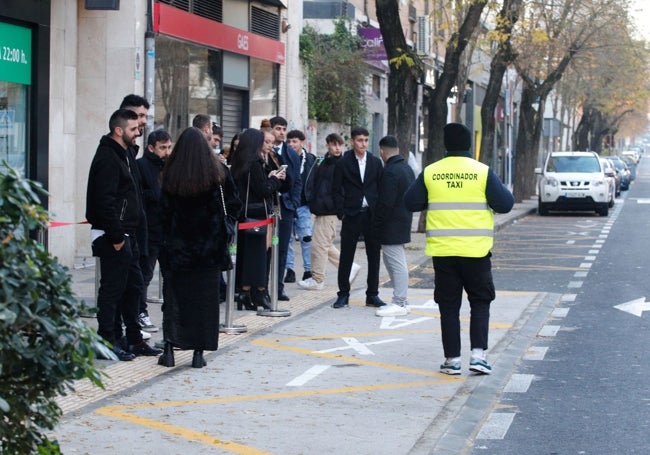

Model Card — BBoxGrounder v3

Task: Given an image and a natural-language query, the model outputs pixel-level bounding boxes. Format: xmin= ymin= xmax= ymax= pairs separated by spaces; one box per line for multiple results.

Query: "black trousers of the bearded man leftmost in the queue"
xmin=93 ymin=235 xmax=144 ymax=344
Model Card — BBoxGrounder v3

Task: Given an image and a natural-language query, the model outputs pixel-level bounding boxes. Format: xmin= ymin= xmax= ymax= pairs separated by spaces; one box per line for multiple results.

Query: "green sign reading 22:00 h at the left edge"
xmin=0 ymin=22 xmax=32 ymax=85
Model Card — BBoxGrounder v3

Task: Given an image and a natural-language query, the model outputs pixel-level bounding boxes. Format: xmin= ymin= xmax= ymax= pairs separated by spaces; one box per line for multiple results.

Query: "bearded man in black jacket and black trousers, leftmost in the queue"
xmin=86 ymin=109 xmax=162 ymax=360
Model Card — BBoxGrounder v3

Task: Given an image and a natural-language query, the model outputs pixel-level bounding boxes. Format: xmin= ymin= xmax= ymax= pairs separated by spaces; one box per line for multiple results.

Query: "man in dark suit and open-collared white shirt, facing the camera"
xmin=332 ymin=127 xmax=386 ymax=308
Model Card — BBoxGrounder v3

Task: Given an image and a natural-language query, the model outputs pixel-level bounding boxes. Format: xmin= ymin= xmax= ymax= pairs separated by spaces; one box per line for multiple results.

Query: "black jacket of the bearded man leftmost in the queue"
xmin=86 ymin=135 xmax=143 ymax=244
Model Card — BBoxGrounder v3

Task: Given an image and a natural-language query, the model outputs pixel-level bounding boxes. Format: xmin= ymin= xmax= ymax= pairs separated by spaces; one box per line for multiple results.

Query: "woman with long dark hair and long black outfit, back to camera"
xmin=158 ymin=127 xmax=241 ymax=368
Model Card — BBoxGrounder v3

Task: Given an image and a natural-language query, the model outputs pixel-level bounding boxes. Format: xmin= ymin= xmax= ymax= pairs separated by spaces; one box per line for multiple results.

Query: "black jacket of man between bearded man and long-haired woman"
xmin=137 ymin=149 xmax=165 ymax=245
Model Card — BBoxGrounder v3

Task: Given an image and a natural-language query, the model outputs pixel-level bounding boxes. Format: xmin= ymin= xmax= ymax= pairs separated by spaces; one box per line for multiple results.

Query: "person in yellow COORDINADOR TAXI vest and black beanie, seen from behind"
xmin=404 ymin=123 xmax=514 ymax=375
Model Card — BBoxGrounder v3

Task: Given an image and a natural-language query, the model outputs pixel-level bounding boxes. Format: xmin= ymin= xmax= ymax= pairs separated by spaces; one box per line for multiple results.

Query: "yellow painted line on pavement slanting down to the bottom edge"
xmin=95 ymin=406 xmax=271 ymax=455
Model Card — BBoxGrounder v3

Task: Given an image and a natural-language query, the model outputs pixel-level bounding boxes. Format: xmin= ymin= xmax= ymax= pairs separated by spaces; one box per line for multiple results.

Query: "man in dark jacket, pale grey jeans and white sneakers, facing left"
xmin=372 ymin=136 xmax=415 ymax=316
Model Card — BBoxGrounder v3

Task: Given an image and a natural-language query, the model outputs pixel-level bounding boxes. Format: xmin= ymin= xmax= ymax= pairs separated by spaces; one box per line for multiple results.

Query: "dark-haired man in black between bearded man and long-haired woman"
xmin=137 ymin=130 xmax=172 ymax=332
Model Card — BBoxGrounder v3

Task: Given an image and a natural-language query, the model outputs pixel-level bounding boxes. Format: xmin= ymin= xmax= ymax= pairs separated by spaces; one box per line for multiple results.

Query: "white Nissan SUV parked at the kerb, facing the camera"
xmin=535 ymin=152 xmax=610 ymax=216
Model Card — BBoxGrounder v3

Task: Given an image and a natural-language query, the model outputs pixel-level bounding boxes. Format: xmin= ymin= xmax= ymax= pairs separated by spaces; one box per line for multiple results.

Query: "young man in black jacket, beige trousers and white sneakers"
xmin=298 ymin=133 xmax=361 ymax=291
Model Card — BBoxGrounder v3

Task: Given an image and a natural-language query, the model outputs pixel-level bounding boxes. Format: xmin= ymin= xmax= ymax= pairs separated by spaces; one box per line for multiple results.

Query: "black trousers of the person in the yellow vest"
xmin=433 ymin=254 xmax=495 ymax=357
